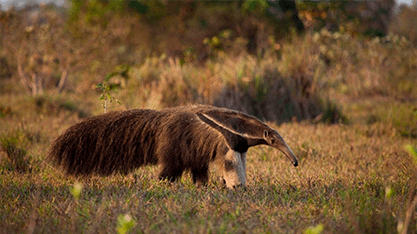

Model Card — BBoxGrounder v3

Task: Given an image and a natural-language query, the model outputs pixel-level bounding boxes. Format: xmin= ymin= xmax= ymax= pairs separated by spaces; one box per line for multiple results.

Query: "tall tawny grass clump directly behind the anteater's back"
xmin=127 ymin=50 xmax=321 ymax=123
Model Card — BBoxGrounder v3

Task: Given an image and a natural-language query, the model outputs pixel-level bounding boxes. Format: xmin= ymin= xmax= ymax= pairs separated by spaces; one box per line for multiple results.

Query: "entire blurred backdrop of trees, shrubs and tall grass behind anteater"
xmin=0 ymin=0 xmax=417 ymax=123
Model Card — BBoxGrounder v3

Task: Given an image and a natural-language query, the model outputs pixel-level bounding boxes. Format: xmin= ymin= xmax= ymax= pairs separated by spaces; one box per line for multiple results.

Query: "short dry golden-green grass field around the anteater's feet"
xmin=0 ymin=95 xmax=417 ymax=233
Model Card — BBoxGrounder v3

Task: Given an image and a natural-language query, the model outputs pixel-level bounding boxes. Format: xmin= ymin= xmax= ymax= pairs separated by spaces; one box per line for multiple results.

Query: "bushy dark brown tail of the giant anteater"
xmin=47 ymin=110 xmax=158 ymax=176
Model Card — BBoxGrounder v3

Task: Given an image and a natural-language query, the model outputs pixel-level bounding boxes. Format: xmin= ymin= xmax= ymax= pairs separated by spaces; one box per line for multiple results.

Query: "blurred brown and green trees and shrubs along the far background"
xmin=0 ymin=0 xmax=410 ymax=97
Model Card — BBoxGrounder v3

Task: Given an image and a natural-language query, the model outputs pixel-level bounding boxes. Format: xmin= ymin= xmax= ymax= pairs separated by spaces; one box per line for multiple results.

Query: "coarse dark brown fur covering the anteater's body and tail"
xmin=47 ymin=105 xmax=296 ymax=183
